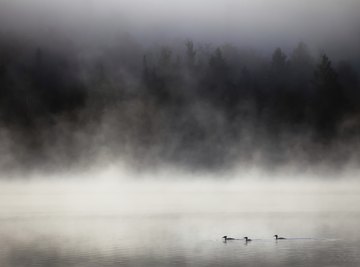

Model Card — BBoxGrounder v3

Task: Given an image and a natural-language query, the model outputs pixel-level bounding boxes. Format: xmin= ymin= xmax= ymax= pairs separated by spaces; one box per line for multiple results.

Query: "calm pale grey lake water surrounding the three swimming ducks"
xmin=0 ymin=179 xmax=360 ymax=267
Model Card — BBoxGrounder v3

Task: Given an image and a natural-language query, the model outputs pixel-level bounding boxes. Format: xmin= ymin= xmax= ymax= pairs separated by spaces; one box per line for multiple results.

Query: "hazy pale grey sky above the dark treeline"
xmin=0 ymin=0 xmax=360 ymax=54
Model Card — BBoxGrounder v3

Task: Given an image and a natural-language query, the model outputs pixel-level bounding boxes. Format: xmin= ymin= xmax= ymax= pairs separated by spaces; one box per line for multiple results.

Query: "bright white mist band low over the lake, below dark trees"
xmin=0 ymin=170 xmax=360 ymax=216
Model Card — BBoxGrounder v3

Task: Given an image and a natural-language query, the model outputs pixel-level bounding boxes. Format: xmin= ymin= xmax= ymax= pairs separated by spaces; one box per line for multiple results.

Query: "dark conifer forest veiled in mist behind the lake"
xmin=0 ymin=34 xmax=360 ymax=171
